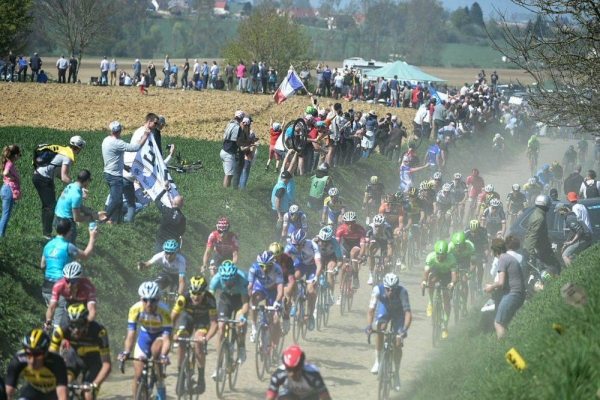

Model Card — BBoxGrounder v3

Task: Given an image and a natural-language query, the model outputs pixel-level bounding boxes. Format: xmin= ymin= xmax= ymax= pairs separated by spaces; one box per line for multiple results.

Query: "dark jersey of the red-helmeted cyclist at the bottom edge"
xmin=267 ymin=364 xmax=327 ymax=400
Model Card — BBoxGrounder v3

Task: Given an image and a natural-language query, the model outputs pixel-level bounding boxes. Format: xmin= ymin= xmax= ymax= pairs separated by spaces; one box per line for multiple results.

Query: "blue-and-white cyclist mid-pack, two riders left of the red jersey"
xmin=285 ymin=229 xmax=322 ymax=330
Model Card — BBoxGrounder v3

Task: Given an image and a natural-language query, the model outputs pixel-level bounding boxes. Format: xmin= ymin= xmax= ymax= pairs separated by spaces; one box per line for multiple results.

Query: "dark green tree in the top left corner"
xmin=0 ymin=0 xmax=32 ymax=56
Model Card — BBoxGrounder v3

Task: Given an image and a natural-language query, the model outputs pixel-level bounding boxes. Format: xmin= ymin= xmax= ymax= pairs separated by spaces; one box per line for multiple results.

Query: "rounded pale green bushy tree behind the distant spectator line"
xmin=223 ymin=7 xmax=311 ymax=81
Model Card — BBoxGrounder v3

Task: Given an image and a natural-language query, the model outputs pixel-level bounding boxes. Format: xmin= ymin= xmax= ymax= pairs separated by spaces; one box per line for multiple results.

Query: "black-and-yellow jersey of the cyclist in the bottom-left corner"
xmin=6 ymin=350 xmax=67 ymax=393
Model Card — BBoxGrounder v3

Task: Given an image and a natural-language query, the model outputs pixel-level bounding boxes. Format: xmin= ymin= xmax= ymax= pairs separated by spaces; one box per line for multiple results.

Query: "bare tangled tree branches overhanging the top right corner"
xmin=492 ymin=0 xmax=600 ymax=131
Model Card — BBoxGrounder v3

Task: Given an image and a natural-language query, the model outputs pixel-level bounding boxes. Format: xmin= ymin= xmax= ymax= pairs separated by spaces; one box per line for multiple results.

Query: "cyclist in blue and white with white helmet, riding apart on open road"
xmin=367 ymin=273 xmax=412 ymax=391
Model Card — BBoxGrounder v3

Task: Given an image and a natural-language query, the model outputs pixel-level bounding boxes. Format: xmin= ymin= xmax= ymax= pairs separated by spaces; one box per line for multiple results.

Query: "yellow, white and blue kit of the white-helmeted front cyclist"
xmin=127 ymin=300 xmax=172 ymax=356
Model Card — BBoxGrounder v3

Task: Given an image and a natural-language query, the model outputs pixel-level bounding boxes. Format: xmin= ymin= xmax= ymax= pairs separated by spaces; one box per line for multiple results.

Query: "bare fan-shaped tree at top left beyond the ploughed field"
xmin=38 ymin=0 xmax=119 ymax=69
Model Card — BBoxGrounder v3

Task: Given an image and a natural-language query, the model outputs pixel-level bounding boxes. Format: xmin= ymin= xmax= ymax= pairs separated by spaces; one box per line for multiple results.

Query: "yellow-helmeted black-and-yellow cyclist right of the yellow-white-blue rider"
xmin=171 ymin=275 xmax=217 ymax=394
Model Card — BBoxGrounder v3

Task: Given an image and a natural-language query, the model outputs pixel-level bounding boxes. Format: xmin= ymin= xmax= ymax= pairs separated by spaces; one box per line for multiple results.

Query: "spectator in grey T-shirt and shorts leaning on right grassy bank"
xmin=485 ymin=235 xmax=525 ymax=339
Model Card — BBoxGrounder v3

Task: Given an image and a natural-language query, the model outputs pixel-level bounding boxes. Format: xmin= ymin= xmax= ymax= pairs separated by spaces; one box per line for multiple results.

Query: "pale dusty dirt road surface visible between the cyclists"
xmin=102 ymin=139 xmax=572 ymax=400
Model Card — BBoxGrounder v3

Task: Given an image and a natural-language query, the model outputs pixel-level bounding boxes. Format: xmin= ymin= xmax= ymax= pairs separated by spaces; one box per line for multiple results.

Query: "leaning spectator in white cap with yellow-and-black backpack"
xmin=32 ymin=136 xmax=85 ymax=240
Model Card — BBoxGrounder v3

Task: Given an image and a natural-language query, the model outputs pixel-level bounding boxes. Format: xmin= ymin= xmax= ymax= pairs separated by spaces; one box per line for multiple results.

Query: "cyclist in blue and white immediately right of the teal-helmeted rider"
xmin=248 ymin=251 xmax=283 ymax=356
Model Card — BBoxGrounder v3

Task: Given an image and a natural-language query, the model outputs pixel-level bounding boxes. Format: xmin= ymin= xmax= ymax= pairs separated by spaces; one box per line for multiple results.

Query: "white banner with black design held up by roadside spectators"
xmin=131 ymin=135 xmax=179 ymax=208
